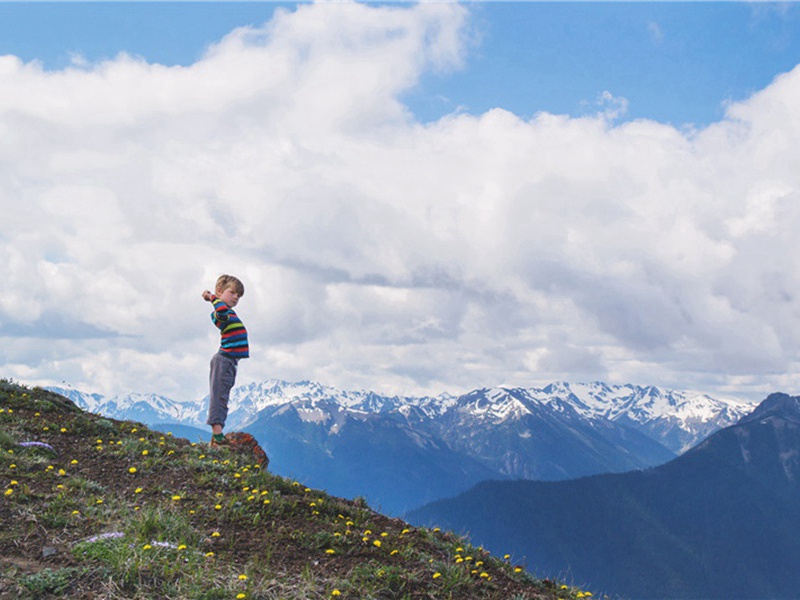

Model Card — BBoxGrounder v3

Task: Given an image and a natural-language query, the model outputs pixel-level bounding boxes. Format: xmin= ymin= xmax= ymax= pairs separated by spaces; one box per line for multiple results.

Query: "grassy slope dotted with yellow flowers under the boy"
xmin=0 ymin=380 xmax=587 ymax=600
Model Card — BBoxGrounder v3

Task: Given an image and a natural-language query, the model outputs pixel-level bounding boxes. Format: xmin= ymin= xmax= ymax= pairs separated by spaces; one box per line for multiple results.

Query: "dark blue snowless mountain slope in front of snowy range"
xmin=408 ymin=394 xmax=800 ymax=600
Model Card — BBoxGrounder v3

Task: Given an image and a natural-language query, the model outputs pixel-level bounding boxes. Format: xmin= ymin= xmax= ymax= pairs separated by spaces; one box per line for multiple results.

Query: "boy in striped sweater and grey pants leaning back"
xmin=203 ymin=275 xmax=250 ymax=446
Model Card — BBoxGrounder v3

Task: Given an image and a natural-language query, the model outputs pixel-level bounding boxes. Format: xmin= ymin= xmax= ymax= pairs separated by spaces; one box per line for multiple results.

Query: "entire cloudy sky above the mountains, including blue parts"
xmin=0 ymin=2 xmax=800 ymax=401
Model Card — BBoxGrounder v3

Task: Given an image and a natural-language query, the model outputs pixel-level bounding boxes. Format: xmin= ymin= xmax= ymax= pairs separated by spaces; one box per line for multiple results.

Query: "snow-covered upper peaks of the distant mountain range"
xmin=51 ymin=379 xmax=754 ymax=454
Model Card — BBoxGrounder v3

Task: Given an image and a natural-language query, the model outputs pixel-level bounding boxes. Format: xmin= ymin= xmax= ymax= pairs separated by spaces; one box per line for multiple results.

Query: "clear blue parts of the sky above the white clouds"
xmin=0 ymin=2 xmax=800 ymax=126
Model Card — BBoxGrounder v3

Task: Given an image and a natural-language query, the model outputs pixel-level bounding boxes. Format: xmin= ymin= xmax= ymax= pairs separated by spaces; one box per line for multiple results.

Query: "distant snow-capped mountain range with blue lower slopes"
xmin=50 ymin=380 xmax=753 ymax=515
